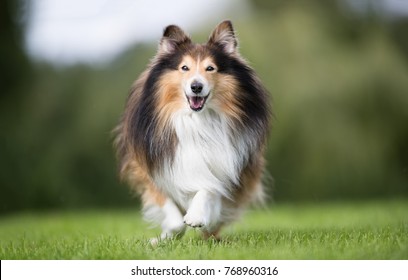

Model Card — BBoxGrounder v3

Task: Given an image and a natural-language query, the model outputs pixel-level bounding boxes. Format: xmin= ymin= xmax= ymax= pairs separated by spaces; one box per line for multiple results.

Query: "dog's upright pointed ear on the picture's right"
xmin=208 ymin=20 xmax=238 ymax=54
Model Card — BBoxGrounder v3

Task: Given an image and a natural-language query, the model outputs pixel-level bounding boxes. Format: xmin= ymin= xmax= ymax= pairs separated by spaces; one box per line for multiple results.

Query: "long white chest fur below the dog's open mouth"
xmin=155 ymin=110 xmax=249 ymax=209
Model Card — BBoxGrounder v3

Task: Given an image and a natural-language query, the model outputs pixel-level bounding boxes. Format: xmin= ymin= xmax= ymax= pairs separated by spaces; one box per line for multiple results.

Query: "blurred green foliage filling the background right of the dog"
xmin=245 ymin=0 xmax=408 ymax=200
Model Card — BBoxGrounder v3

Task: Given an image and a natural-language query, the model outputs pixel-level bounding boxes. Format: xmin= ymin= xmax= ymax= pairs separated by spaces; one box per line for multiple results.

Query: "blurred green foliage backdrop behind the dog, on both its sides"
xmin=0 ymin=0 xmax=408 ymax=214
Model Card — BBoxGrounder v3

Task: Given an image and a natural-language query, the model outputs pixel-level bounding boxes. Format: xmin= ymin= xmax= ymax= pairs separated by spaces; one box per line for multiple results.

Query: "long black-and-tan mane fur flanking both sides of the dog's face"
xmin=119 ymin=49 xmax=270 ymax=178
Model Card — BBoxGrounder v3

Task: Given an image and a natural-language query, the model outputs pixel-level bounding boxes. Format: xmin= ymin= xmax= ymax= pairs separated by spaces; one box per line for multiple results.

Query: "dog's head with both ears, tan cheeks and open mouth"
xmin=158 ymin=21 xmax=237 ymax=112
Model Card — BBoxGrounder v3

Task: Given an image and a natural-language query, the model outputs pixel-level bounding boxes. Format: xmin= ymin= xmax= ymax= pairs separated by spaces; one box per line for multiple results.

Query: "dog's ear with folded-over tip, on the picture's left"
xmin=159 ymin=25 xmax=191 ymax=54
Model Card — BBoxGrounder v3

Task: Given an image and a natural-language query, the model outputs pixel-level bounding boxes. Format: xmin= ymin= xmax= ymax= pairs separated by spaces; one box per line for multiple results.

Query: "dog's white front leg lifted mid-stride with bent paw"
xmin=184 ymin=190 xmax=222 ymax=230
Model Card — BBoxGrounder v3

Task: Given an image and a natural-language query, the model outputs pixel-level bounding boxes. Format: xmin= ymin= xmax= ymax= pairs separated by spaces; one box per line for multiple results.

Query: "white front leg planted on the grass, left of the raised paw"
xmin=150 ymin=199 xmax=186 ymax=245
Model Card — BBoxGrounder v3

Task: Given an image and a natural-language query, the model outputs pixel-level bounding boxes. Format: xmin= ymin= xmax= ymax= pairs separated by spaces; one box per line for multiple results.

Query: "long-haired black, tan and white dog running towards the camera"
xmin=115 ymin=20 xmax=271 ymax=244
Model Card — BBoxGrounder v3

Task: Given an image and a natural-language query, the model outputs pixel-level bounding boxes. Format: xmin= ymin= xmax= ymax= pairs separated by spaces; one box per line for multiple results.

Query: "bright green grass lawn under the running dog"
xmin=0 ymin=200 xmax=408 ymax=260
